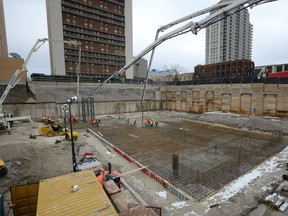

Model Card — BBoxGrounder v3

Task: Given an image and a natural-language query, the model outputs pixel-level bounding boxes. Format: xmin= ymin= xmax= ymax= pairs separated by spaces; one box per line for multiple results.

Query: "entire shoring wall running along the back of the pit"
xmin=3 ymin=82 xmax=288 ymax=120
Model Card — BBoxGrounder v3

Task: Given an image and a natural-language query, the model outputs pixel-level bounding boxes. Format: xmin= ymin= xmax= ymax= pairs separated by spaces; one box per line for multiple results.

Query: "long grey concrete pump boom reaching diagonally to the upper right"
xmin=88 ymin=0 xmax=275 ymax=98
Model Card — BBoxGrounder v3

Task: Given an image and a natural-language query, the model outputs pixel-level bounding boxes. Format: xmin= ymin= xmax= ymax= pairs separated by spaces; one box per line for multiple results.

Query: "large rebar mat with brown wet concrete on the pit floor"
xmin=94 ymin=114 xmax=287 ymax=200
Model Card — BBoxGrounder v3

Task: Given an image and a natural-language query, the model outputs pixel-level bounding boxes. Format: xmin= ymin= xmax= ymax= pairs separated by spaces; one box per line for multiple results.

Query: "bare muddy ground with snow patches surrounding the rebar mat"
xmin=0 ymin=112 xmax=288 ymax=216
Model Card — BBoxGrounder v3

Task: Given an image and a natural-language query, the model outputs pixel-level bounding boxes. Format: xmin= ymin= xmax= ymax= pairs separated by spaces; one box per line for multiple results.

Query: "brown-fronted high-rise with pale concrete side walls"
xmin=46 ymin=0 xmax=133 ymax=78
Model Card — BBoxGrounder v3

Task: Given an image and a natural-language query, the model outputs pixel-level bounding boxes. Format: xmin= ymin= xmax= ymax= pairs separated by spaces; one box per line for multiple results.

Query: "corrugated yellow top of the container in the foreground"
xmin=37 ymin=170 xmax=118 ymax=216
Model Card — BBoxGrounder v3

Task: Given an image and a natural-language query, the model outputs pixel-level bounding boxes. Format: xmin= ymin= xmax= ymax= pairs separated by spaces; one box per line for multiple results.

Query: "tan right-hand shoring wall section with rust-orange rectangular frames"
xmin=160 ymin=83 xmax=288 ymax=116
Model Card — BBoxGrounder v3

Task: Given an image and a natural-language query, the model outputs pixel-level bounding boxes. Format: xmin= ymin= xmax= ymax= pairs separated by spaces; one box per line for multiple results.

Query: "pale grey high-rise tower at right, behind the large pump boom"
xmin=205 ymin=0 xmax=253 ymax=64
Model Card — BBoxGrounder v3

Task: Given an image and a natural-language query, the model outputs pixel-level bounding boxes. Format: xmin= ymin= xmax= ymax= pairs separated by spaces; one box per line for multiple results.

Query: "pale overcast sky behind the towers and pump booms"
xmin=3 ymin=0 xmax=288 ymax=74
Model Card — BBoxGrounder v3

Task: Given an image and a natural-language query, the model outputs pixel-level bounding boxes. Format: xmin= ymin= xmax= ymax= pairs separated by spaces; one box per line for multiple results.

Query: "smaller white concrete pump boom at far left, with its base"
xmin=0 ymin=38 xmax=81 ymax=131
